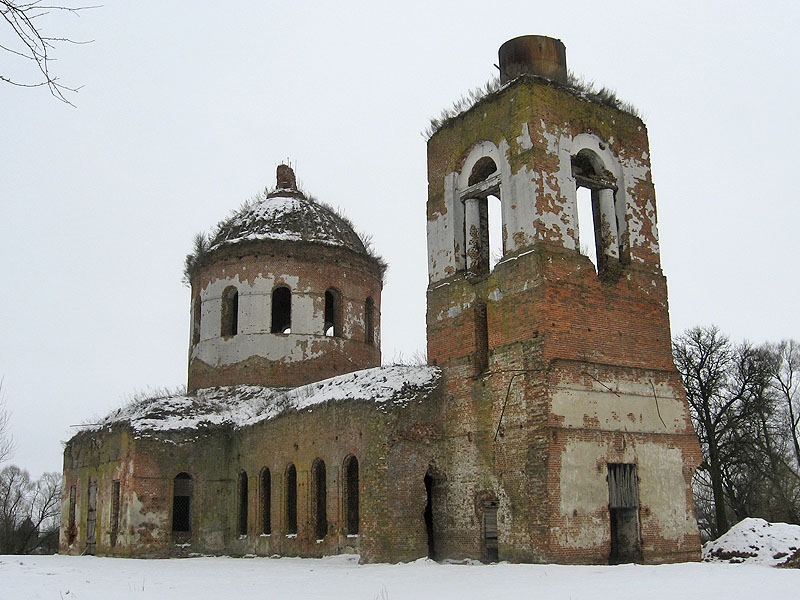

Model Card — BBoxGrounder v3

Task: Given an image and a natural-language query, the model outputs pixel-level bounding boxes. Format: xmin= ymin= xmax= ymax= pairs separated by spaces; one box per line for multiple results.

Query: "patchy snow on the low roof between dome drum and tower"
xmin=86 ymin=366 xmax=441 ymax=432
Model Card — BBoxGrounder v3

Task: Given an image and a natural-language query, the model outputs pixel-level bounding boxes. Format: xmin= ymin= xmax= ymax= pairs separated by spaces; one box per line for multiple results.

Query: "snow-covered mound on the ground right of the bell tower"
xmin=703 ymin=518 xmax=800 ymax=565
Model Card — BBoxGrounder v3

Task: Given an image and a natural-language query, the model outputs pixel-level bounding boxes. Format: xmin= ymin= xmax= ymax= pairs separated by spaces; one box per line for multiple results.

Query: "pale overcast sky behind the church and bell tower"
xmin=0 ymin=0 xmax=800 ymax=475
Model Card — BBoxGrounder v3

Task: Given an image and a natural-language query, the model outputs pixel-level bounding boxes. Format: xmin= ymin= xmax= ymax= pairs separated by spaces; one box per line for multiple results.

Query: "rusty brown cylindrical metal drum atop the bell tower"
xmin=497 ymin=35 xmax=567 ymax=84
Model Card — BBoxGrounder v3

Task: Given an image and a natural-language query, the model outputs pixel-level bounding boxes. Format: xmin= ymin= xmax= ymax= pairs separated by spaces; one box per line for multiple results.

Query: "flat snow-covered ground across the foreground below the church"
xmin=0 ymin=555 xmax=800 ymax=600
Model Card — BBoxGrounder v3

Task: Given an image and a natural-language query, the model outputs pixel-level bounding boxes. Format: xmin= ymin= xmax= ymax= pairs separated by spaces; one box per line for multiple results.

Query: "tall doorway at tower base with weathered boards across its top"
xmin=608 ymin=464 xmax=641 ymax=563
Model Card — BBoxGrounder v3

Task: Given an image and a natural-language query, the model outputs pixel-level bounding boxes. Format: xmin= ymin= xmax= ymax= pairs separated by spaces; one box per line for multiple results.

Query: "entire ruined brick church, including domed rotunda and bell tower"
xmin=60 ymin=36 xmax=700 ymax=564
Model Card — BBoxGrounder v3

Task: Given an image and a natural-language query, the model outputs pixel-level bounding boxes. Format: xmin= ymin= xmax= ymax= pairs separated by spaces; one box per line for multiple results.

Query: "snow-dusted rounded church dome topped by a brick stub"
xmin=209 ymin=165 xmax=369 ymax=256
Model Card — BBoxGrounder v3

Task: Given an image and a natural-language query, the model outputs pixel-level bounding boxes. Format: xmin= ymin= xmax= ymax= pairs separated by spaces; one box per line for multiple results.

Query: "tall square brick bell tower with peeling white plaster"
xmin=427 ymin=36 xmax=700 ymax=563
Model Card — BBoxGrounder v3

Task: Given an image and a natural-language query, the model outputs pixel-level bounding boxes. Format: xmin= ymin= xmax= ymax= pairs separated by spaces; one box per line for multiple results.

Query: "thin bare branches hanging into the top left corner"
xmin=0 ymin=0 xmax=95 ymax=105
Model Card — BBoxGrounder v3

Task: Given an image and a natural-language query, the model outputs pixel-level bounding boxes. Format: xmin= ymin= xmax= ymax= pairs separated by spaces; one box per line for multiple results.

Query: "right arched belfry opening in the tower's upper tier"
xmin=572 ymin=148 xmax=620 ymax=273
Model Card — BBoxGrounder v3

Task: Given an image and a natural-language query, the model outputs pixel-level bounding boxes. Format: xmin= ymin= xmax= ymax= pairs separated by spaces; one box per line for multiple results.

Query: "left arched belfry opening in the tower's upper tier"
xmin=461 ymin=156 xmax=504 ymax=276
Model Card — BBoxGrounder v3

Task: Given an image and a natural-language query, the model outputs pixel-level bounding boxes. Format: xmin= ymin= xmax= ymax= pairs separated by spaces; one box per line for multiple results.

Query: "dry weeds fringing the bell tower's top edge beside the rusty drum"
xmin=423 ymin=71 xmax=642 ymax=140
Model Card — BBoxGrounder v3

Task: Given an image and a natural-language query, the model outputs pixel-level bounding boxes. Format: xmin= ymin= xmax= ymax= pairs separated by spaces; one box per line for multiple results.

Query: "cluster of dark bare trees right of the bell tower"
xmin=672 ymin=326 xmax=800 ymax=539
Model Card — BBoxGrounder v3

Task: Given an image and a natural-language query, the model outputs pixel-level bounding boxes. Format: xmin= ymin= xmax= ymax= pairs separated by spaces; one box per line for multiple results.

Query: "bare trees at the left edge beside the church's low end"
xmin=0 ymin=380 xmax=61 ymax=554
